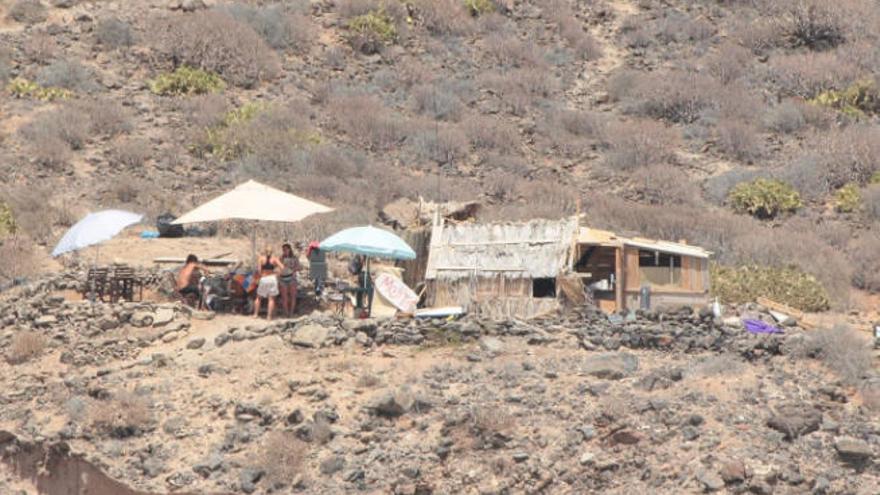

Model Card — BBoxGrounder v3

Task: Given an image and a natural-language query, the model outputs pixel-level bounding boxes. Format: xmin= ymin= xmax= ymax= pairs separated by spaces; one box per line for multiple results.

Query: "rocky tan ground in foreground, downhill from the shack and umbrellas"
xmin=0 ymin=277 xmax=880 ymax=494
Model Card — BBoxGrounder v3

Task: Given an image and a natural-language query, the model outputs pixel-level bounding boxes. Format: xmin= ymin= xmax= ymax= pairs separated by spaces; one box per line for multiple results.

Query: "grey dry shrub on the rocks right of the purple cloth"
xmin=794 ymin=324 xmax=873 ymax=385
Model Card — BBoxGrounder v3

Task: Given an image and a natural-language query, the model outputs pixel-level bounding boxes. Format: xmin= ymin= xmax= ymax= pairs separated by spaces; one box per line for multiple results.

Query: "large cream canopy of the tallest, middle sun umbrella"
xmin=172 ymin=180 xmax=333 ymax=224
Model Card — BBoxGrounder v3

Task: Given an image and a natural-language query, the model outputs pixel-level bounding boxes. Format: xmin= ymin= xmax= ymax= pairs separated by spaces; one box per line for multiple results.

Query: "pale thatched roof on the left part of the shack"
xmin=425 ymin=217 xmax=578 ymax=280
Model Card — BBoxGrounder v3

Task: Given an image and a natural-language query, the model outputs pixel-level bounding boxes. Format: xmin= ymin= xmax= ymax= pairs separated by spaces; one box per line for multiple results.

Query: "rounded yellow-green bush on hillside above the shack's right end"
xmin=727 ymin=178 xmax=803 ymax=219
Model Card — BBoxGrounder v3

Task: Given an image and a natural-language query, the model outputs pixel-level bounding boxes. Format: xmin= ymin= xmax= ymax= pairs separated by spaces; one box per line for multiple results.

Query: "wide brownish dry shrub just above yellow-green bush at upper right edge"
xmin=764 ymin=52 xmax=861 ymax=99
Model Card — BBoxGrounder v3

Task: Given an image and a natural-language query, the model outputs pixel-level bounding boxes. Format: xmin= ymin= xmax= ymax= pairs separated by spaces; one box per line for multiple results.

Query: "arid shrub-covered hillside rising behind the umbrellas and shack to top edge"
xmin=0 ymin=0 xmax=880 ymax=298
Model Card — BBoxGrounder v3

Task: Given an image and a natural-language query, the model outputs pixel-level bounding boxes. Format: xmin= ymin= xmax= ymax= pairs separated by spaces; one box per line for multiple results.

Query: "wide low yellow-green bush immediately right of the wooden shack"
xmin=710 ymin=264 xmax=831 ymax=311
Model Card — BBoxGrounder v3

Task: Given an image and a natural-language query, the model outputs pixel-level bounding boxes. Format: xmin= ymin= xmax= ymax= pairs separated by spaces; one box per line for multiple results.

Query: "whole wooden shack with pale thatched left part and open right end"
xmin=425 ymin=217 xmax=711 ymax=318
